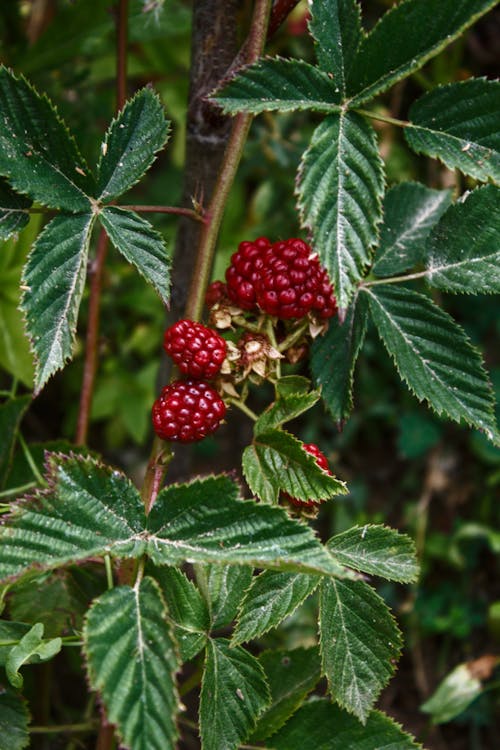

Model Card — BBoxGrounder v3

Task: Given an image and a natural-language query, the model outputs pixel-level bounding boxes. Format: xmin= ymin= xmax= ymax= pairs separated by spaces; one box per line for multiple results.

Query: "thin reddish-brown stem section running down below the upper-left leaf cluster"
xmin=75 ymin=229 xmax=108 ymax=445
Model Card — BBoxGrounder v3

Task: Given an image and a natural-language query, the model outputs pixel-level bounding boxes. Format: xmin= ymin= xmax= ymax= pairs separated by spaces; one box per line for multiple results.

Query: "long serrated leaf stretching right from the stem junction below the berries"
xmin=146 ymin=476 xmax=343 ymax=575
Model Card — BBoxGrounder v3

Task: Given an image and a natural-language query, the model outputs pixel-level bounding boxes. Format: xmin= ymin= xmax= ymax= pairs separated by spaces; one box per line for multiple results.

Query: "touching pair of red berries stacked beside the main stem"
xmin=152 ymin=320 xmax=226 ymax=443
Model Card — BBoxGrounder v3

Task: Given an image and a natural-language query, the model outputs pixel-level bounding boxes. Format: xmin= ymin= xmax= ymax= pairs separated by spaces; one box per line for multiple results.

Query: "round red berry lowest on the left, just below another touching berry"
xmin=152 ymin=380 xmax=226 ymax=443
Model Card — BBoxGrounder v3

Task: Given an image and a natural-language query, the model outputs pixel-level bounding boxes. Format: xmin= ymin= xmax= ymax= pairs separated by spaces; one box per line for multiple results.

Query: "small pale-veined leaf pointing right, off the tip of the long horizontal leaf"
xmin=327 ymin=524 xmax=418 ymax=583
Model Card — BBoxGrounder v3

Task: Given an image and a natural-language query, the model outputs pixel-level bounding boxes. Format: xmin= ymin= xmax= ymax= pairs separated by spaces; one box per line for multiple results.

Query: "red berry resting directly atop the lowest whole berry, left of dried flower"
xmin=163 ymin=320 xmax=227 ymax=378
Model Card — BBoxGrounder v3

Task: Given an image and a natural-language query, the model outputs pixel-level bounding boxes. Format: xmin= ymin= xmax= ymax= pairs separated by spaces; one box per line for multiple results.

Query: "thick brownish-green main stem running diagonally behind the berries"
xmin=141 ymin=0 xmax=272 ymax=513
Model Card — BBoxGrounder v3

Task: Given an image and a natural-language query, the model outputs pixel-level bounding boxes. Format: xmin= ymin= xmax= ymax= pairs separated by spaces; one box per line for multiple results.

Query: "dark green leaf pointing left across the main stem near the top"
xmin=210 ymin=57 xmax=340 ymax=114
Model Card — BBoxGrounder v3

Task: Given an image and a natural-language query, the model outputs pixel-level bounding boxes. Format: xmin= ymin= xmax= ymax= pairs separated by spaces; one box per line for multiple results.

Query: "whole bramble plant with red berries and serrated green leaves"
xmin=0 ymin=0 xmax=500 ymax=750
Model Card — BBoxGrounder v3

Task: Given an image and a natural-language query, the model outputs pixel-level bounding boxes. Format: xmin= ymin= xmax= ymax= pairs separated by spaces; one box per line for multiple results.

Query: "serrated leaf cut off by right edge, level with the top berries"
xmin=426 ymin=185 xmax=500 ymax=294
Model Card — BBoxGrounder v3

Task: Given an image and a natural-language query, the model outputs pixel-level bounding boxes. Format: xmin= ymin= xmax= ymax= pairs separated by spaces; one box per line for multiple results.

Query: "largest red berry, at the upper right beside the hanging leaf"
xmin=255 ymin=238 xmax=336 ymax=319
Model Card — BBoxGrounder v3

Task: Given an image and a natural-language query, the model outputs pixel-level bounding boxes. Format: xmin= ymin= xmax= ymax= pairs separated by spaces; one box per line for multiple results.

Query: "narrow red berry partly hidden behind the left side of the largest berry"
xmin=226 ymin=237 xmax=271 ymax=310
